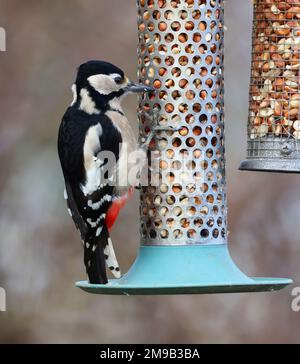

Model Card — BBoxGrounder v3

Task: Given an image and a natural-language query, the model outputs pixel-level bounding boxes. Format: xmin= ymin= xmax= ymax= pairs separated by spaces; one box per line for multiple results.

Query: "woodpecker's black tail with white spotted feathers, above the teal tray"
xmin=84 ymin=224 xmax=121 ymax=284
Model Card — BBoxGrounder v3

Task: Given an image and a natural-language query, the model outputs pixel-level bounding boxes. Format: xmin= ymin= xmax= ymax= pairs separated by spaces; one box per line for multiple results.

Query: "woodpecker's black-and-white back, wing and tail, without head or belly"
xmin=58 ymin=107 xmax=122 ymax=283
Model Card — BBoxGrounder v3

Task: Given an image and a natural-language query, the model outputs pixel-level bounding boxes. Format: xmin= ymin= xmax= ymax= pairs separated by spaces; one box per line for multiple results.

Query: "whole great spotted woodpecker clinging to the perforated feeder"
xmin=58 ymin=61 xmax=152 ymax=284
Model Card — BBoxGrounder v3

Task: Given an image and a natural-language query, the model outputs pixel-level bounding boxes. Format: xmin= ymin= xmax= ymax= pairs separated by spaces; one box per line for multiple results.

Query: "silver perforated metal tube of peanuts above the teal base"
xmin=138 ymin=0 xmax=227 ymax=245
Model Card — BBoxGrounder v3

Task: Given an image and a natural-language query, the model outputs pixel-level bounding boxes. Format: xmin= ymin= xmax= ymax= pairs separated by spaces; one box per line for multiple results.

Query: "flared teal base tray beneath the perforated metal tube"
xmin=76 ymin=244 xmax=293 ymax=296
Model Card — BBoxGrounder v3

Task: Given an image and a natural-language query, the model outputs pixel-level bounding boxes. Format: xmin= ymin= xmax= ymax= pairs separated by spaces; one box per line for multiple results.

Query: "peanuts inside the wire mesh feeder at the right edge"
xmin=249 ymin=0 xmax=300 ymax=140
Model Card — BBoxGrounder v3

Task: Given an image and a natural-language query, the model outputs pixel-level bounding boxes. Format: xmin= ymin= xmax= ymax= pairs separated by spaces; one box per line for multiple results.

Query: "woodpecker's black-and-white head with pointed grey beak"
xmin=72 ymin=61 xmax=152 ymax=114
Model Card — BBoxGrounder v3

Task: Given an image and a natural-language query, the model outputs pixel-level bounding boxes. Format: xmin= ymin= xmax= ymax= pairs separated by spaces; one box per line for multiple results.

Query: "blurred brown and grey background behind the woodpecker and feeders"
xmin=0 ymin=0 xmax=300 ymax=343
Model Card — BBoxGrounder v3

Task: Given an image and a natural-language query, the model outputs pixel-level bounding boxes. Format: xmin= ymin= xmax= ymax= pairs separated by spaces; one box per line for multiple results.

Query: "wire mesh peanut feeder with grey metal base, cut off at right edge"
xmin=240 ymin=0 xmax=300 ymax=173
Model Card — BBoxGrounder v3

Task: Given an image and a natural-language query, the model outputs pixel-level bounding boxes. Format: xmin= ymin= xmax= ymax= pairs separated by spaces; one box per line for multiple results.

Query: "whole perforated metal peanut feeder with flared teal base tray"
xmin=77 ymin=0 xmax=292 ymax=295
